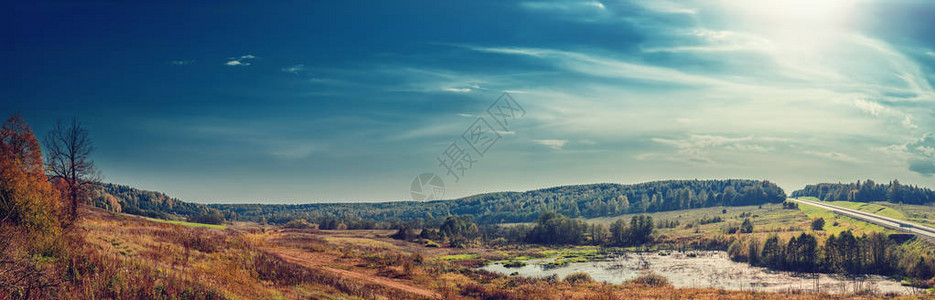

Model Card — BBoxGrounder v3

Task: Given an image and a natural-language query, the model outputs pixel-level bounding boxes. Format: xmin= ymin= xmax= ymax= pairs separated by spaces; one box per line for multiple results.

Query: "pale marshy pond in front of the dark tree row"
xmin=481 ymin=251 xmax=912 ymax=294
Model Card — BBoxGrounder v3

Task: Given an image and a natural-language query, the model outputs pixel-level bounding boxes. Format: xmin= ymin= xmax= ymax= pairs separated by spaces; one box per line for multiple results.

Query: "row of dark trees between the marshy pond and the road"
xmin=727 ymin=231 xmax=935 ymax=280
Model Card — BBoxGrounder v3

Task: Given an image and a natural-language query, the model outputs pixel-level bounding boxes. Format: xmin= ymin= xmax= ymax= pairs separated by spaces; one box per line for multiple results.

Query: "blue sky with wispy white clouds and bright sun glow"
xmin=0 ymin=0 xmax=935 ymax=203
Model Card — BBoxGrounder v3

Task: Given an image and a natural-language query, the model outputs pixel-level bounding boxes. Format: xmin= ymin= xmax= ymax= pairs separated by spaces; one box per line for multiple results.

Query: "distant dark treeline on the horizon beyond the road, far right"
xmin=792 ymin=179 xmax=935 ymax=205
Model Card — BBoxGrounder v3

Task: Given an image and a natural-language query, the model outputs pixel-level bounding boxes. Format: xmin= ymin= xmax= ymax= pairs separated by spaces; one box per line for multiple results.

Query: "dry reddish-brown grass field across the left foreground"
xmin=7 ymin=208 xmax=916 ymax=299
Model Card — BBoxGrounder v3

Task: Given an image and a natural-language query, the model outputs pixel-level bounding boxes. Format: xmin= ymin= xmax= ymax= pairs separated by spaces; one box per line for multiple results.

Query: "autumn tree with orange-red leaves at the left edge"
xmin=0 ymin=114 xmax=66 ymax=299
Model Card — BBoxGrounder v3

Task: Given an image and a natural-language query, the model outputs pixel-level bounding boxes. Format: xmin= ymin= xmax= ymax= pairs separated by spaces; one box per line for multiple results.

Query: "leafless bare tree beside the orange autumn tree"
xmin=43 ymin=119 xmax=101 ymax=222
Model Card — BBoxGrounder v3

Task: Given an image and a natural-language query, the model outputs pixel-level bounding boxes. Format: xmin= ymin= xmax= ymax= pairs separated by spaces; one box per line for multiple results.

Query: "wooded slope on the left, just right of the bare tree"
xmin=91 ymin=183 xmax=227 ymax=223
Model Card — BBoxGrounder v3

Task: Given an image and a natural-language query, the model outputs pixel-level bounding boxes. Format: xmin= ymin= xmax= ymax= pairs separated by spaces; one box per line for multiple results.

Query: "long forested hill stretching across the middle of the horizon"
xmin=214 ymin=179 xmax=785 ymax=228
